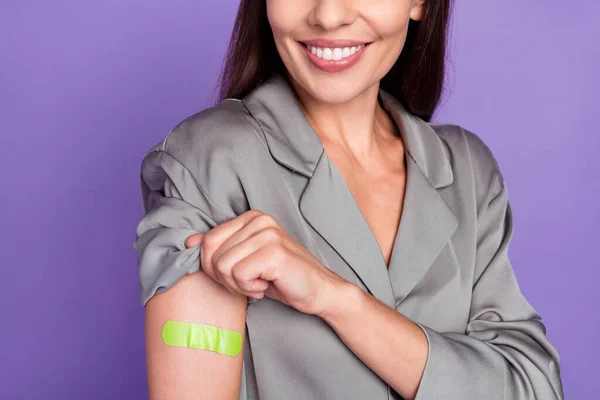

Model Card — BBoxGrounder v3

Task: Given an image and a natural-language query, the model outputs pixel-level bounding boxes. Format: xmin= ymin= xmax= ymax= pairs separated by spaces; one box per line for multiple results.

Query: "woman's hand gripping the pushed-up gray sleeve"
xmin=185 ymin=210 xmax=350 ymax=315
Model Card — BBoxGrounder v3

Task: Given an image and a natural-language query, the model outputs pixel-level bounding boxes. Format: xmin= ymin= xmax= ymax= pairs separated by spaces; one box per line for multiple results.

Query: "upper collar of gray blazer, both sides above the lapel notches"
xmin=242 ymin=74 xmax=454 ymax=188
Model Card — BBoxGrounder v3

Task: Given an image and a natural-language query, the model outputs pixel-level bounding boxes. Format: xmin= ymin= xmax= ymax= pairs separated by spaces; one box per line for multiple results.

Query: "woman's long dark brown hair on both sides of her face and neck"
xmin=219 ymin=0 xmax=452 ymax=121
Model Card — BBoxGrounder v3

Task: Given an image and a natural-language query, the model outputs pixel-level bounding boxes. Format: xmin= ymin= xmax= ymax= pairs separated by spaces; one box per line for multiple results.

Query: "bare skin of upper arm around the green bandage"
xmin=145 ymin=271 xmax=247 ymax=400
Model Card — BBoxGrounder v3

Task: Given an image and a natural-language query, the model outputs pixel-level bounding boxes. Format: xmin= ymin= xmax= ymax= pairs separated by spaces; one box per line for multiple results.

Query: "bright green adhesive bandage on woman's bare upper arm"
xmin=162 ymin=321 xmax=243 ymax=356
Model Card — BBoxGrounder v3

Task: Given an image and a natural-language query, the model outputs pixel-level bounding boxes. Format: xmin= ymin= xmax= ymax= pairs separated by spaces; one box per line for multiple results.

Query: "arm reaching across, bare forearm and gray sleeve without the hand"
xmin=321 ymin=175 xmax=563 ymax=400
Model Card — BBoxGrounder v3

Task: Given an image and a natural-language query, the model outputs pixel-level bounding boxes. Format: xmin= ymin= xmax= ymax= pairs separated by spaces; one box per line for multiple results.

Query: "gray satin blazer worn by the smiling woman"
xmin=134 ymin=75 xmax=563 ymax=400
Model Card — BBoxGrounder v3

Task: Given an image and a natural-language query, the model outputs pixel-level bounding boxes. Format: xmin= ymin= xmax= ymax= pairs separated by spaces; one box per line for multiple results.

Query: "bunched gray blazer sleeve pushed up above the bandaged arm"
xmin=133 ymin=149 xmax=229 ymax=306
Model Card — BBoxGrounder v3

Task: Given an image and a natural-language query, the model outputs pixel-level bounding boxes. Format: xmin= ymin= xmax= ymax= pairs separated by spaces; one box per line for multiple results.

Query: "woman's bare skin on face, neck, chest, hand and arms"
xmin=146 ymin=0 xmax=428 ymax=399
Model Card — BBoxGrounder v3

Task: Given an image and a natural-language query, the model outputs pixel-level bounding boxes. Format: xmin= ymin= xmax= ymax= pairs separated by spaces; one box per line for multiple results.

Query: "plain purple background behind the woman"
xmin=0 ymin=0 xmax=600 ymax=400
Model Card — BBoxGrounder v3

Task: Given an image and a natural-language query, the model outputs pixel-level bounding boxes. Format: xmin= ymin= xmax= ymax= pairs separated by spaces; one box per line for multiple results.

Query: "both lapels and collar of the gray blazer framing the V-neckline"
xmin=242 ymin=75 xmax=457 ymax=308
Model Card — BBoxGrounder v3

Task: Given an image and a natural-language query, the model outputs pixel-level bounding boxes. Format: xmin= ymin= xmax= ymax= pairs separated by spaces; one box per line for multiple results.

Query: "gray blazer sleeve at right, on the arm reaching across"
xmin=416 ymin=172 xmax=564 ymax=400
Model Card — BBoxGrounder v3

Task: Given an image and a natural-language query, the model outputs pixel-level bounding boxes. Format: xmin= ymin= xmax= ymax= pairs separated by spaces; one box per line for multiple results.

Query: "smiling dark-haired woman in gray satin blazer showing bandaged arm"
xmin=134 ymin=0 xmax=563 ymax=400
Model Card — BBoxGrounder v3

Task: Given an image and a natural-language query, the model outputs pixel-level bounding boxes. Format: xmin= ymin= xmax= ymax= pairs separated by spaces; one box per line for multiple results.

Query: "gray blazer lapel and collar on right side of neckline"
xmin=380 ymin=91 xmax=458 ymax=306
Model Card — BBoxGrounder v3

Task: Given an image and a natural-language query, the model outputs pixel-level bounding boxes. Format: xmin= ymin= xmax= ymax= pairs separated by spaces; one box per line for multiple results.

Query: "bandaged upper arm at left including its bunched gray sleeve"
xmin=134 ymin=149 xmax=247 ymax=400
